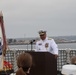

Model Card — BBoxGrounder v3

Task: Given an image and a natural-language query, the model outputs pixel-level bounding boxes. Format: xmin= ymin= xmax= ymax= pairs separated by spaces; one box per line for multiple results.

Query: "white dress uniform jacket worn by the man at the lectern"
xmin=36 ymin=37 xmax=58 ymax=55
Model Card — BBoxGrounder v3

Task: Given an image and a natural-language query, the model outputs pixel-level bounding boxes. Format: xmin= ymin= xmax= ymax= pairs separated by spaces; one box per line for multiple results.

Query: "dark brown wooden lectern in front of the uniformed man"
xmin=28 ymin=52 xmax=57 ymax=75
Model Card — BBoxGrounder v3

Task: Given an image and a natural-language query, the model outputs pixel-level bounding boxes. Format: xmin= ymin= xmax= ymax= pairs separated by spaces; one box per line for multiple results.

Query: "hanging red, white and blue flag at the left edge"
xmin=0 ymin=12 xmax=6 ymax=70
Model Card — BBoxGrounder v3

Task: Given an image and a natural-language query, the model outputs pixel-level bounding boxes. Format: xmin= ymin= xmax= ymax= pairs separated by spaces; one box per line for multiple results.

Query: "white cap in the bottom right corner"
xmin=61 ymin=64 xmax=76 ymax=75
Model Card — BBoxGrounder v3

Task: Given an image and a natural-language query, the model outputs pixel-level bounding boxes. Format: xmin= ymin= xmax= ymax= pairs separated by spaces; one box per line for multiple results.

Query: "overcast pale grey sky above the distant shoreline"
xmin=0 ymin=0 xmax=76 ymax=38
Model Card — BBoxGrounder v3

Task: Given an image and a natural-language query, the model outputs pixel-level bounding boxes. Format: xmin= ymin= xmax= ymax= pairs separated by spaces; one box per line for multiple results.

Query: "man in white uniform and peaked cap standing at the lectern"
xmin=36 ymin=30 xmax=58 ymax=58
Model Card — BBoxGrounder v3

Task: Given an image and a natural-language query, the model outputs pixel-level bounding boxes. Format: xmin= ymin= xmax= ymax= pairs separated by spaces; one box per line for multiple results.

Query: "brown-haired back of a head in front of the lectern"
xmin=16 ymin=53 xmax=32 ymax=75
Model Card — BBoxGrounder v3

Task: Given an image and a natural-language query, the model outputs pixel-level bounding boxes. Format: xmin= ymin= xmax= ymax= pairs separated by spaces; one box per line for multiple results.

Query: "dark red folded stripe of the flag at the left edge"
xmin=0 ymin=12 xmax=7 ymax=55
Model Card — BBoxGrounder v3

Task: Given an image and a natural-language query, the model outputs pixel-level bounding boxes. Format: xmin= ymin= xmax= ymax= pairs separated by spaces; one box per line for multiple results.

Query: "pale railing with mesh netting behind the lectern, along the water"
xmin=4 ymin=49 xmax=76 ymax=71
